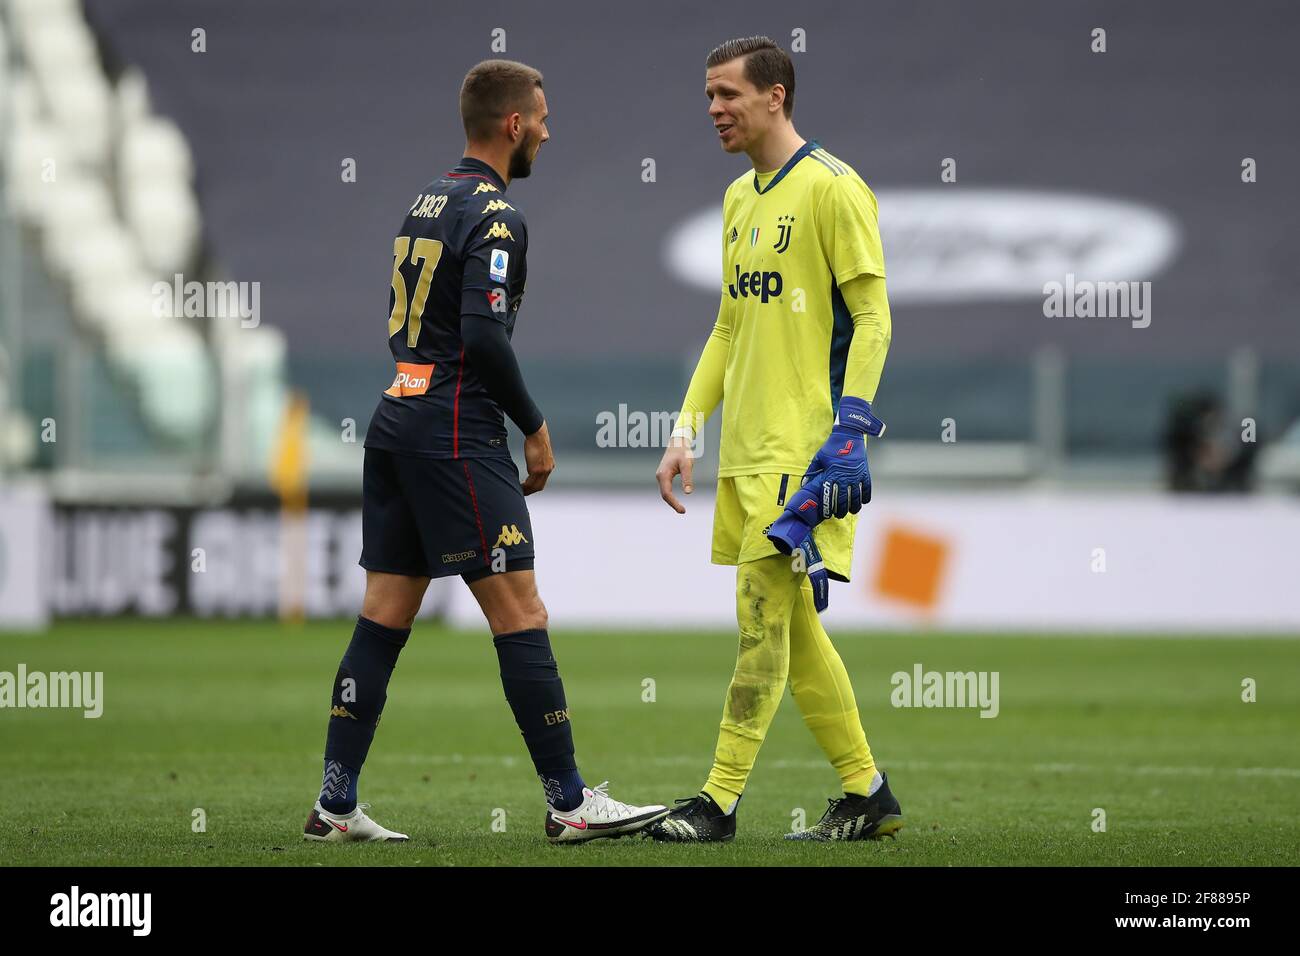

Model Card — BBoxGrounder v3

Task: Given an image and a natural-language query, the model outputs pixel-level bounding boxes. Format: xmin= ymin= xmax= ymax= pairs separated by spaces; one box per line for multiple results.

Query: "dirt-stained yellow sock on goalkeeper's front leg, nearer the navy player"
xmin=703 ymin=554 xmax=802 ymax=810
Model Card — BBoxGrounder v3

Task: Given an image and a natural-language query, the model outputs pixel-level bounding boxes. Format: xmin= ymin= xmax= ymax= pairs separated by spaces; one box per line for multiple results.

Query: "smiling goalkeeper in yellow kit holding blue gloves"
xmin=650 ymin=36 xmax=902 ymax=843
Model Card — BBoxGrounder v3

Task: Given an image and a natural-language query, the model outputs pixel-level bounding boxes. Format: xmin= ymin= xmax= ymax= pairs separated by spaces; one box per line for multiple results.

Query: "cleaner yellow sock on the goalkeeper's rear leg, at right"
xmin=789 ymin=581 xmax=876 ymax=796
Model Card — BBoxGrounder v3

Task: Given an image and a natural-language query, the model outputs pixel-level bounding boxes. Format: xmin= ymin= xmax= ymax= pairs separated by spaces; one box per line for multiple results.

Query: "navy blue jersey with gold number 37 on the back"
xmin=365 ymin=157 xmax=528 ymax=458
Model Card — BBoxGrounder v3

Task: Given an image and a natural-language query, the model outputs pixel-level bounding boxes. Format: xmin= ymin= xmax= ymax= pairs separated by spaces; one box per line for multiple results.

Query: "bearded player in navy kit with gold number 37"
xmin=304 ymin=60 xmax=667 ymax=843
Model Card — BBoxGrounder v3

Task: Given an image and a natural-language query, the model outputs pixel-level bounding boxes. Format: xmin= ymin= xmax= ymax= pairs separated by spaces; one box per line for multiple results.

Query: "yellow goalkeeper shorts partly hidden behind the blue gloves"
xmin=712 ymin=475 xmax=858 ymax=581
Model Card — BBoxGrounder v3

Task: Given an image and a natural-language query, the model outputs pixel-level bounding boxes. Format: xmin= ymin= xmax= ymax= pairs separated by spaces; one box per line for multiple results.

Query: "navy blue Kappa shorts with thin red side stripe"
xmin=360 ymin=449 xmax=533 ymax=580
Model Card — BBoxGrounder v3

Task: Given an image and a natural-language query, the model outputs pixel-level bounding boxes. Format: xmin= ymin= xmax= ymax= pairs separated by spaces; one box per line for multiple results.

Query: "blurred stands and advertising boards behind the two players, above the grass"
xmin=0 ymin=0 xmax=1300 ymax=633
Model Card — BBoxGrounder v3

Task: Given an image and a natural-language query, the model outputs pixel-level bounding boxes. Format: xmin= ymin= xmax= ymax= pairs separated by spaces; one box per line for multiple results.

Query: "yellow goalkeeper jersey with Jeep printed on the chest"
xmin=683 ymin=142 xmax=888 ymax=477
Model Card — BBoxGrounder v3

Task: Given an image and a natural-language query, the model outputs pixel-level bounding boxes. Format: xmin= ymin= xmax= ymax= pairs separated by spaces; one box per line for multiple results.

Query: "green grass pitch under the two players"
xmin=0 ymin=620 xmax=1300 ymax=866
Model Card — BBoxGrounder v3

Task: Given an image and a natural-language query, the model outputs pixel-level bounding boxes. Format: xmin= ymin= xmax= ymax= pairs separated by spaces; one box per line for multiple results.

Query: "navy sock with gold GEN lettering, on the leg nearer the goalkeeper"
xmin=493 ymin=628 xmax=585 ymax=810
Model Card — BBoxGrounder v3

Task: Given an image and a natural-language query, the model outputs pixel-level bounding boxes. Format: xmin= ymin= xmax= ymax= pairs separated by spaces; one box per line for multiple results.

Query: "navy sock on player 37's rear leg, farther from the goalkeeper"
xmin=320 ymin=618 xmax=411 ymax=813
